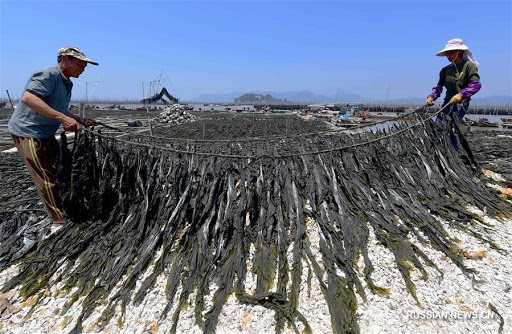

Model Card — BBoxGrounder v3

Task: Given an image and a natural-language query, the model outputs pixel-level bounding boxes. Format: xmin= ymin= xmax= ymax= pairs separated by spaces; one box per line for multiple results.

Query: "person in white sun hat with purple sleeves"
xmin=425 ymin=38 xmax=481 ymax=149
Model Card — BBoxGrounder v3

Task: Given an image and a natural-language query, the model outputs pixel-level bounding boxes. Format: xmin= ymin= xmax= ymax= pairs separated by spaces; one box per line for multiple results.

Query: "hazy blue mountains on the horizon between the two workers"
xmin=191 ymin=90 xmax=366 ymax=103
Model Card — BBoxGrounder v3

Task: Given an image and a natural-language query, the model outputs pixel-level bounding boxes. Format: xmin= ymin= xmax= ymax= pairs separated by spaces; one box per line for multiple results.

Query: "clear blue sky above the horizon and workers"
xmin=0 ymin=0 xmax=512 ymax=99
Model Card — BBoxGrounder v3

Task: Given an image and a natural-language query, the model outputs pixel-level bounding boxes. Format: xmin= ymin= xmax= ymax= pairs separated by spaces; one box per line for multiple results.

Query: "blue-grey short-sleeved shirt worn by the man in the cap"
xmin=8 ymin=66 xmax=73 ymax=138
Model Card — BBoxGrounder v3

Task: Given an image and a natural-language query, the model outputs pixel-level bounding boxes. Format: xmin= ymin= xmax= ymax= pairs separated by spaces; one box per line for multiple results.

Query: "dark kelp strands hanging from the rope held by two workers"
xmin=1 ymin=109 xmax=511 ymax=333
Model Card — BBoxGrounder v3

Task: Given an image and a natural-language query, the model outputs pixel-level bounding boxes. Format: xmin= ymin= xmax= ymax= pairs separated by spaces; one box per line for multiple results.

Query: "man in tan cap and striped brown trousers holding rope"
xmin=8 ymin=46 xmax=98 ymax=227
